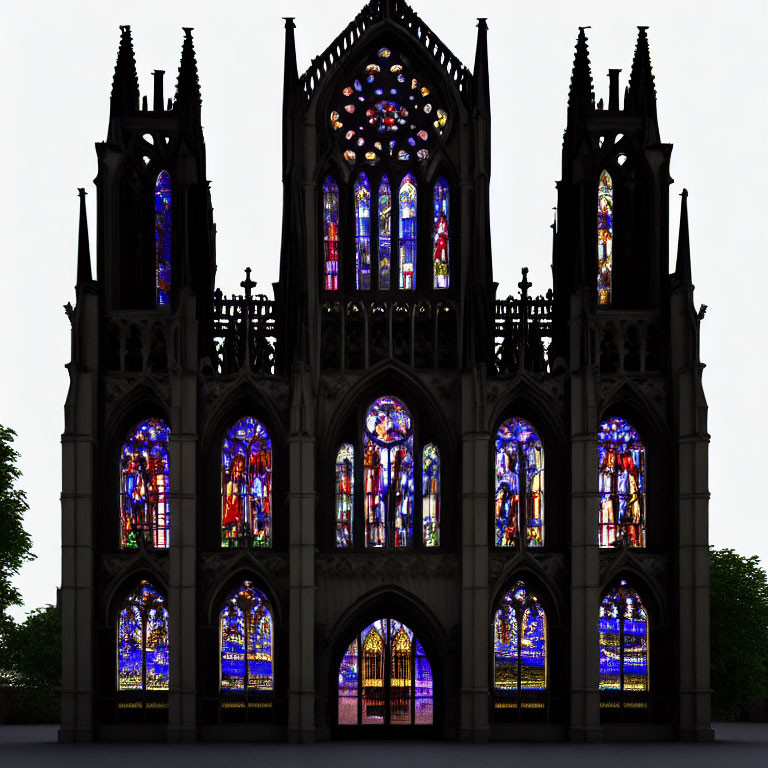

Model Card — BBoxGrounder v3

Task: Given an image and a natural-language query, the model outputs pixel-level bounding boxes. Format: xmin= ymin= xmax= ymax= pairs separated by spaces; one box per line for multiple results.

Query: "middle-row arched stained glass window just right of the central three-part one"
xmin=495 ymin=418 xmax=544 ymax=547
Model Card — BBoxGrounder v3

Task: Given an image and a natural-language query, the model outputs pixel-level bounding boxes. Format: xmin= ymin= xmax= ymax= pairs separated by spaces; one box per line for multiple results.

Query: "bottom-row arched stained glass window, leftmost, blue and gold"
xmin=117 ymin=581 xmax=169 ymax=691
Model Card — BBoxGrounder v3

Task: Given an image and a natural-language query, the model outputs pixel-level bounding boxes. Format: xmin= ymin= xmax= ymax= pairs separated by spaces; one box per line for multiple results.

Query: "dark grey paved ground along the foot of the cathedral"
xmin=0 ymin=723 xmax=768 ymax=768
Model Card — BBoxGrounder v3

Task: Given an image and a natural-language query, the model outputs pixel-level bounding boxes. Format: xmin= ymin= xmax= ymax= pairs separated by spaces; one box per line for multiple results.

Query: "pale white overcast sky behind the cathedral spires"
xmin=0 ymin=0 xmax=768 ymax=615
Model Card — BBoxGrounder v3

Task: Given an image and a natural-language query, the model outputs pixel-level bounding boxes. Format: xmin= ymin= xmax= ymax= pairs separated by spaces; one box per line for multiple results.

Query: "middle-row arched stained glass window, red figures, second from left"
xmin=221 ymin=417 xmax=272 ymax=547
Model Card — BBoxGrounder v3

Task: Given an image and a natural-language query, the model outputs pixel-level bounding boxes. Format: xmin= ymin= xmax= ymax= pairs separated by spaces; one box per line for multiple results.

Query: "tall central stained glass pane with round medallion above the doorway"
xmin=363 ymin=397 xmax=414 ymax=547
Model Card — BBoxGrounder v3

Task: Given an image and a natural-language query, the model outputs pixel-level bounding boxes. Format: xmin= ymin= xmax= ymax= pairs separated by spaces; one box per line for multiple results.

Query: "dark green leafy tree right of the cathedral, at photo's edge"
xmin=709 ymin=549 xmax=768 ymax=720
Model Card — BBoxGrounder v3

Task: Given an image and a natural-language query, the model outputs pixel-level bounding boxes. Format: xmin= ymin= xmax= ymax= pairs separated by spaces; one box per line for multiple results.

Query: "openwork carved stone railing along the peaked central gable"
xmin=300 ymin=0 xmax=471 ymax=101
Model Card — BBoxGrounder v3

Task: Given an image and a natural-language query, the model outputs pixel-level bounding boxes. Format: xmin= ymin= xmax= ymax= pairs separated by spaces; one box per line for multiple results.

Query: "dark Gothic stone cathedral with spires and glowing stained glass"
xmin=59 ymin=0 xmax=713 ymax=742
